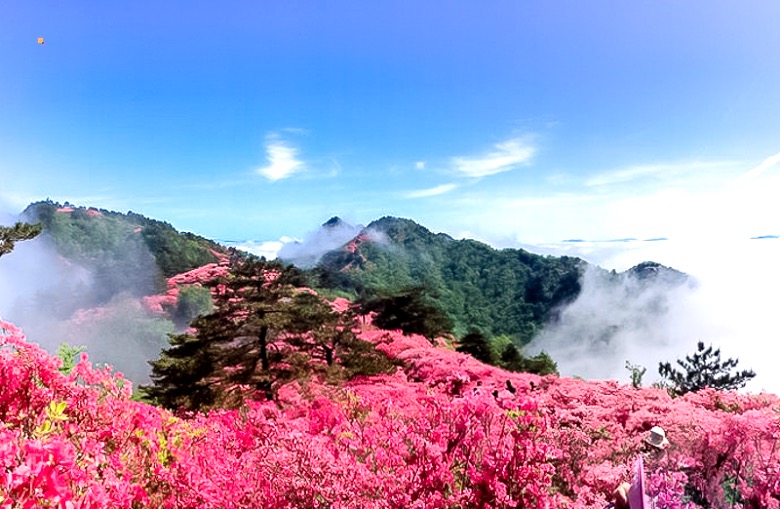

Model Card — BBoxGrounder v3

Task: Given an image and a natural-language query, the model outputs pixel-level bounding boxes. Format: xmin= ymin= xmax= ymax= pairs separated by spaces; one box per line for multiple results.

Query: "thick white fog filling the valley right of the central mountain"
xmin=529 ymin=238 xmax=780 ymax=393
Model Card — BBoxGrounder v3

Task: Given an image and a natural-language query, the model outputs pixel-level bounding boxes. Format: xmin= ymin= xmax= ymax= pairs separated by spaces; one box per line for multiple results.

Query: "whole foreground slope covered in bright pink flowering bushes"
xmin=0 ymin=312 xmax=780 ymax=508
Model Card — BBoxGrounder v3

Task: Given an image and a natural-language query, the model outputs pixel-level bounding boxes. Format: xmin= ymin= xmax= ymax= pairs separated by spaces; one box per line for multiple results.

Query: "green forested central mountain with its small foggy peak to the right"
xmin=315 ymin=217 xmax=687 ymax=345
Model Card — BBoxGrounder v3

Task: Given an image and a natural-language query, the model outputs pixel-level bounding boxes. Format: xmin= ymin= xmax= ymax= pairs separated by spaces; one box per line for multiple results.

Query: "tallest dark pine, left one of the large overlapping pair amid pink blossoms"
xmin=144 ymin=259 xmax=302 ymax=409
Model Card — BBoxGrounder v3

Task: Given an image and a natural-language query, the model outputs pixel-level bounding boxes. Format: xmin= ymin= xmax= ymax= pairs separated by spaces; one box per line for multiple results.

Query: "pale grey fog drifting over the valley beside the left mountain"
xmin=0 ymin=208 xmax=173 ymax=385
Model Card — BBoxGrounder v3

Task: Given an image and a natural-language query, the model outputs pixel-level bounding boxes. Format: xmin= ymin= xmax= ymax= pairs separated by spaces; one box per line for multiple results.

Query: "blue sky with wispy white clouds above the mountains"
xmin=0 ymin=0 xmax=780 ymax=252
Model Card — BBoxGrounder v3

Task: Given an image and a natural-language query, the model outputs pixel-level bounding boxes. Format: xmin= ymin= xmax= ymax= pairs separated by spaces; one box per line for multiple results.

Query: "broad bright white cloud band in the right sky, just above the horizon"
xmin=426 ymin=154 xmax=780 ymax=246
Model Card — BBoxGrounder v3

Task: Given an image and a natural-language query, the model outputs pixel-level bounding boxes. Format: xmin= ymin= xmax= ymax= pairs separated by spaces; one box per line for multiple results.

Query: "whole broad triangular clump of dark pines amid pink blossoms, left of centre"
xmin=143 ymin=259 xmax=393 ymax=410
